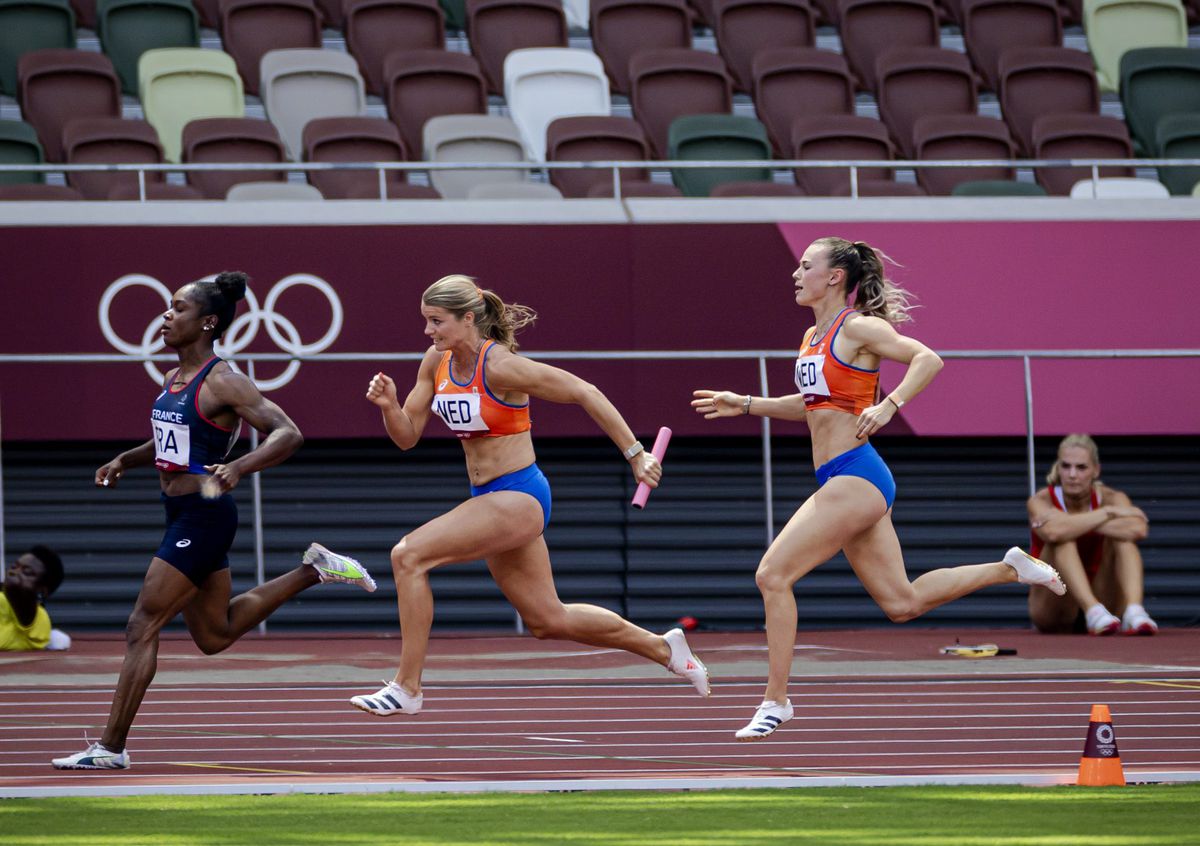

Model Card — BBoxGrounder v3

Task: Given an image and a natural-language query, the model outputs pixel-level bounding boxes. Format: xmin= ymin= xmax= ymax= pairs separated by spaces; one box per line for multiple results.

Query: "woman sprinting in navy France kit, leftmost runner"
xmin=52 ymin=272 xmax=376 ymax=769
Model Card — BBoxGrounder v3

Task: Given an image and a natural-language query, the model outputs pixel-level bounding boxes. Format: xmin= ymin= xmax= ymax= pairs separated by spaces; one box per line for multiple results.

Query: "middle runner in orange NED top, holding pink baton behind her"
xmin=350 ymin=275 xmax=709 ymax=716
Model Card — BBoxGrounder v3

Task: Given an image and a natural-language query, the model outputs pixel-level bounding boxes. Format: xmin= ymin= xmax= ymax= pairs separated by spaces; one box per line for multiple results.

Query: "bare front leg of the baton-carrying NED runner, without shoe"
xmin=391 ymin=491 xmax=542 ymax=695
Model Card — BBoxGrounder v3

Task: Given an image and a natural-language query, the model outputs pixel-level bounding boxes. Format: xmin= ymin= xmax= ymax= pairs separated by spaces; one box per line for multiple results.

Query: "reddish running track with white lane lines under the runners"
xmin=0 ymin=631 xmax=1200 ymax=797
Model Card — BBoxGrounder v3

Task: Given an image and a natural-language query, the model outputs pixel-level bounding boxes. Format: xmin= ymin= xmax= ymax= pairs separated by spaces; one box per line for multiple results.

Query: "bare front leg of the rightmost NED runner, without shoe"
xmin=755 ymin=476 xmax=887 ymax=702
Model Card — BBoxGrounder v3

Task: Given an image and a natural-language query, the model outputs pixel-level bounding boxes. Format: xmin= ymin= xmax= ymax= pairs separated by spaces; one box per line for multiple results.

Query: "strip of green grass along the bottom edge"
xmin=0 ymin=776 xmax=1200 ymax=846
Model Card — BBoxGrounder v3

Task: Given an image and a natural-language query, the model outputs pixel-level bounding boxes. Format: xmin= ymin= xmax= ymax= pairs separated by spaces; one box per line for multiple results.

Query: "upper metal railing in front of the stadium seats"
xmin=0 ymin=158 xmax=1200 ymax=202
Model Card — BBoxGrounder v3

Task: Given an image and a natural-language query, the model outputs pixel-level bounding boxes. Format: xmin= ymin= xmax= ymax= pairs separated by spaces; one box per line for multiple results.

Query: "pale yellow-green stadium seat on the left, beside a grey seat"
xmin=138 ymin=48 xmax=246 ymax=162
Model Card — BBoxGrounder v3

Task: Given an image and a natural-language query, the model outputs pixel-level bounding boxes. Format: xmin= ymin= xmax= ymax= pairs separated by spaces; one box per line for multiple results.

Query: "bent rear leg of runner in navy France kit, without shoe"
xmin=184 ymin=566 xmax=320 ymax=655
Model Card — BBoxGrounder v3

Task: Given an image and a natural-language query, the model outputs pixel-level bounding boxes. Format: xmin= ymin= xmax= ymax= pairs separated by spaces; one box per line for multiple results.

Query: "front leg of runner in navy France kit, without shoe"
xmin=100 ymin=558 xmax=196 ymax=752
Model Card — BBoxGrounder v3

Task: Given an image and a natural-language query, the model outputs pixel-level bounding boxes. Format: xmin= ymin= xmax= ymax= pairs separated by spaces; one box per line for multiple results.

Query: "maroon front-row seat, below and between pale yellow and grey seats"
xmin=182 ymin=118 xmax=288 ymax=199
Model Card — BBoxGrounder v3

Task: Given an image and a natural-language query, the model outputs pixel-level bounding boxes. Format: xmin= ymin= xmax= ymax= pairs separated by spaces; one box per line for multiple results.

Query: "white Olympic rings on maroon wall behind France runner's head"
xmin=100 ymin=274 xmax=343 ymax=391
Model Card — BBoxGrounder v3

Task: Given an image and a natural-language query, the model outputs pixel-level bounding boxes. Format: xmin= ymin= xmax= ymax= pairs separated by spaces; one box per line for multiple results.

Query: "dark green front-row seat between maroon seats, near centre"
xmin=667 ymin=114 xmax=772 ymax=197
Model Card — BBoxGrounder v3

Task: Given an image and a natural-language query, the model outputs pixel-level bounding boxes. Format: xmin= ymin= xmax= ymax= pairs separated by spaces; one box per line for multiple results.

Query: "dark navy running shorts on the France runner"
xmin=154 ymin=493 xmax=238 ymax=587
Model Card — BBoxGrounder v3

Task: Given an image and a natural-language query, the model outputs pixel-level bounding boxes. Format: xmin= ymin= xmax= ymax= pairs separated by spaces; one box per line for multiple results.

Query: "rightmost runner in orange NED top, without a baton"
xmin=691 ymin=238 xmax=1066 ymax=740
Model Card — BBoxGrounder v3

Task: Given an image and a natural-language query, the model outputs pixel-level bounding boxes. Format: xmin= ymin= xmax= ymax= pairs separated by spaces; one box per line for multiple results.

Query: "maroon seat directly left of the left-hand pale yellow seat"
xmin=17 ymin=49 xmax=121 ymax=162
